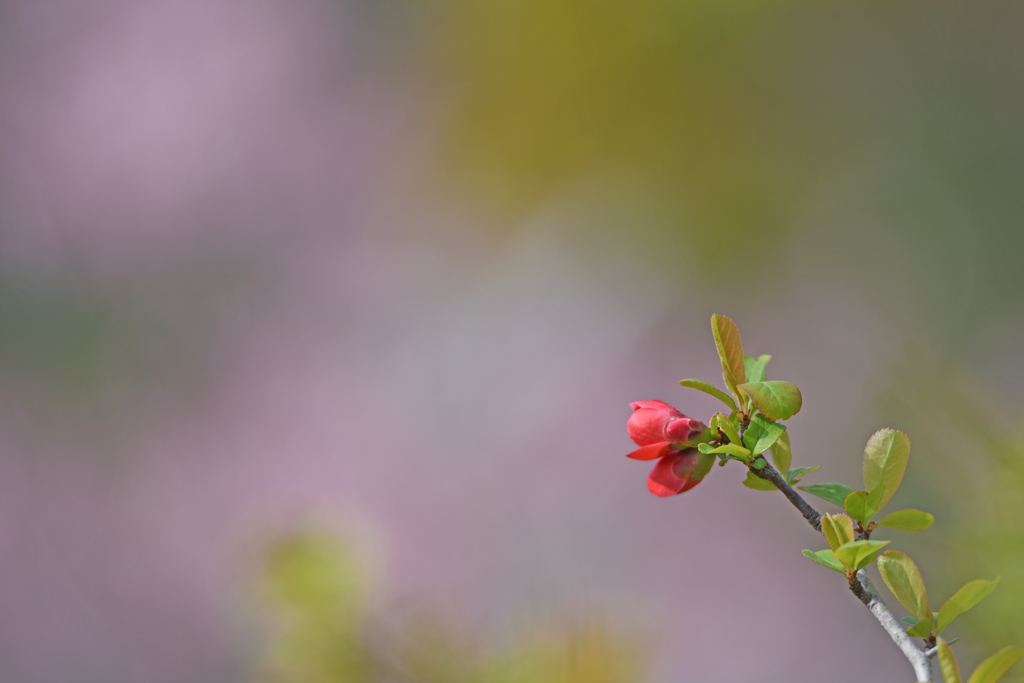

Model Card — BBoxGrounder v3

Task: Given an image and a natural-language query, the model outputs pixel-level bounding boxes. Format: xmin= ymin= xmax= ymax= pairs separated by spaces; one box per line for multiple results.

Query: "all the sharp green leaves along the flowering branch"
xmin=680 ymin=314 xmax=1024 ymax=683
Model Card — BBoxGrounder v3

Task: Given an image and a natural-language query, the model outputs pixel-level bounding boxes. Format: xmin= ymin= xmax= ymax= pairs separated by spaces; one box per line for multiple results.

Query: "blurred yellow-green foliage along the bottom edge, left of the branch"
xmin=254 ymin=532 xmax=649 ymax=683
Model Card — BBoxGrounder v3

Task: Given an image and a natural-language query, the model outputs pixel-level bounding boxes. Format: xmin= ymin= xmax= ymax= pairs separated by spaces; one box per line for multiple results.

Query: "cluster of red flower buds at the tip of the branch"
xmin=626 ymin=400 xmax=715 ymax=498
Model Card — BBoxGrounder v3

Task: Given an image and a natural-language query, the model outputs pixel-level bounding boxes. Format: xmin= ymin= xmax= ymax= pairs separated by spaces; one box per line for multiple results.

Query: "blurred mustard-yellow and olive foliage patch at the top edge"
xmin=432 ymin=0 xmax=806 ymax=252
